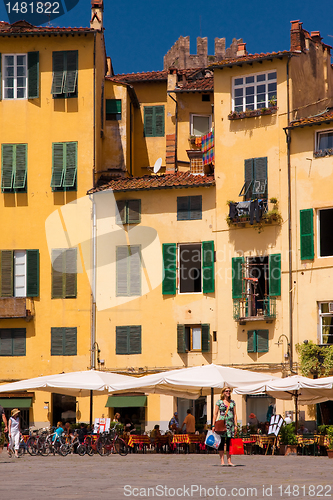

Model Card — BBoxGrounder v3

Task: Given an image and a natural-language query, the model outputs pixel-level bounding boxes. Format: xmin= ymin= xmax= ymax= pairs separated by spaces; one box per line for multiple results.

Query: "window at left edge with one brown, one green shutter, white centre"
xmin=0 ymin=250 xmax=39 ymax=297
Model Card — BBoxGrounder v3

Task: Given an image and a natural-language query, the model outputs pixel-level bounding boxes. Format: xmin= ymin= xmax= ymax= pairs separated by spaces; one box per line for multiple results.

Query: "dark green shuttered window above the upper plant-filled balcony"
xmin=239 ymin=157 xmax=267 ymax=200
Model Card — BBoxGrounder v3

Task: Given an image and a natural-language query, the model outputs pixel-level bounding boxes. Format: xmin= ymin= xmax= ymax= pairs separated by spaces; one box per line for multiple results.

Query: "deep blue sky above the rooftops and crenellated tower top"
xmin=0 ymin=0 xmax=333 ymax=73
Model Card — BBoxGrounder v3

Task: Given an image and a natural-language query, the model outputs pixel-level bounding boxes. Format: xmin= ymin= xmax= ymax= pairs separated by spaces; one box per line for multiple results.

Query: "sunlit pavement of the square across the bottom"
xmin=0 ymin=452 xmax=333 ymax=500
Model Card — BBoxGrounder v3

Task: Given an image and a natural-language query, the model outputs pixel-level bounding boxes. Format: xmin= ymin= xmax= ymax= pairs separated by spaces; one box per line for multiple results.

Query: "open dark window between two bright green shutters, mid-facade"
xmin=162 ymin=241 xmax=215 ymax=295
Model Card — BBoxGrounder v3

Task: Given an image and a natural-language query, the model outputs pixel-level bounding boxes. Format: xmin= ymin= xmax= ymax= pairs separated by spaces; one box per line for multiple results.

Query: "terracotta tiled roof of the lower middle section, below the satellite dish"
xmin=88 ymin=172 xmax=215 ymax=194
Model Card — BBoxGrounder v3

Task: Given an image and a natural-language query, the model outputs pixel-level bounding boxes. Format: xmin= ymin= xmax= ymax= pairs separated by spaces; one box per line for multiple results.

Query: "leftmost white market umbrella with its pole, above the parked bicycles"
xmin=0 ymin=370 xmax=136 ymax=425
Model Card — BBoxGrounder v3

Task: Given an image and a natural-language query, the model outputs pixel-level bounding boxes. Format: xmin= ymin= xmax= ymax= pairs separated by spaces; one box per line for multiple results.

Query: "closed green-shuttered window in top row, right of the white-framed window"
xmin=51 ymin=50 xmax=78 ymax=98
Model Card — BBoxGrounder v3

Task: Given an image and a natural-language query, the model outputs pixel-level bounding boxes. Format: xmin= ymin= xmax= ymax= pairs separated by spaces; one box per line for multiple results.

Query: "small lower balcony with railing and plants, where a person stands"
xmin=233 ymin=297 xmax=276 ymax=325
